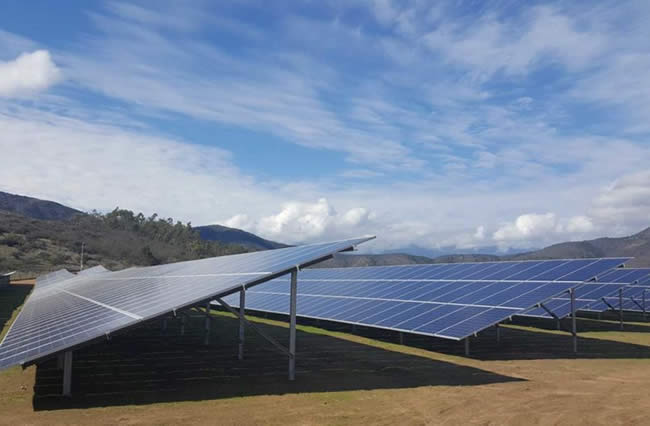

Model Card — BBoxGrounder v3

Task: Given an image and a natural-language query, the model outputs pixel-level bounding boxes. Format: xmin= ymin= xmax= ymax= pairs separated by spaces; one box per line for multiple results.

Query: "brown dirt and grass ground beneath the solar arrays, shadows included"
xmin=0 ymin=285 xmax=650 ymax=425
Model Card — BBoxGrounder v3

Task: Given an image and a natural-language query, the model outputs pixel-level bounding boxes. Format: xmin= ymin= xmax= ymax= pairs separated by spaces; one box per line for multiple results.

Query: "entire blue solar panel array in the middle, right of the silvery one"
xmin=220 ymin=258 xmax=628 ymax=340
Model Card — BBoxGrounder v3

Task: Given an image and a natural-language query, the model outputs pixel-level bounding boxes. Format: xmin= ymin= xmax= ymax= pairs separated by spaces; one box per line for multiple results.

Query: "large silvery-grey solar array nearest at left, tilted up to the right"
xmin=0 ymin=237 xmax=374 ymax=369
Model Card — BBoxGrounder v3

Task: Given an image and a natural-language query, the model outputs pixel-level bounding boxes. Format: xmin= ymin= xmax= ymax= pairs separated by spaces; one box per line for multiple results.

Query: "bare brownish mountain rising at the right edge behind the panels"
xmin=508 ymin=228 xmax=650 ymax=267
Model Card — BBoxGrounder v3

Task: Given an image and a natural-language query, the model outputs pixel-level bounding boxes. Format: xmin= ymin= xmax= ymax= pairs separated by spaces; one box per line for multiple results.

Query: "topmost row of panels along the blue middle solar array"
xmin=302 ymin=258 xmax=629 ymax=282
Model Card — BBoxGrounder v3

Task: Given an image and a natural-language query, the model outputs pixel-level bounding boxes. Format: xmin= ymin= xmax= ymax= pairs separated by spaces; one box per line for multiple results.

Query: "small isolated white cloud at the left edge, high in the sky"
xmin=0 ymin=50 xmax=61 ymax=97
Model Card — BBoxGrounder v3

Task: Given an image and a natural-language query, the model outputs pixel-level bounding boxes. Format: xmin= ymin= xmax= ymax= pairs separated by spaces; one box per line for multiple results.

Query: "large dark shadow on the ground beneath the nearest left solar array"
xmin=33 ymin=316 xmax=522 ymax=410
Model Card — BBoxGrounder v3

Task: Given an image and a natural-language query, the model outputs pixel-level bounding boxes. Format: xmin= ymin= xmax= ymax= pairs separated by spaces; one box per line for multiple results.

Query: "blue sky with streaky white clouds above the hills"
xmin=0 ymin=0 xmax=650 ymax=252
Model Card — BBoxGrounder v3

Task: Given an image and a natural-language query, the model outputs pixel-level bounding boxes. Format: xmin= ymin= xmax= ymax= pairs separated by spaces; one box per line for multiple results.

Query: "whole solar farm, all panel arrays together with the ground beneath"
xmin=0 ymin=237 xmax=650 ymax=424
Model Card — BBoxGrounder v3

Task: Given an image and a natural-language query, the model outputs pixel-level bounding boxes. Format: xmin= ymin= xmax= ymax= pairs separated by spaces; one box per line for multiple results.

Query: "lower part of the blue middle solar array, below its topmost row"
xmin=220 ymin=276 xmax=575 ymax=340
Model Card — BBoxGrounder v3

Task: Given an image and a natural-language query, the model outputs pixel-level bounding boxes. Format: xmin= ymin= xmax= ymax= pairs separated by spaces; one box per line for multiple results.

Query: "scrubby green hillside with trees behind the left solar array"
xmin=0 ymin=209 xmax=246 ymax=276
